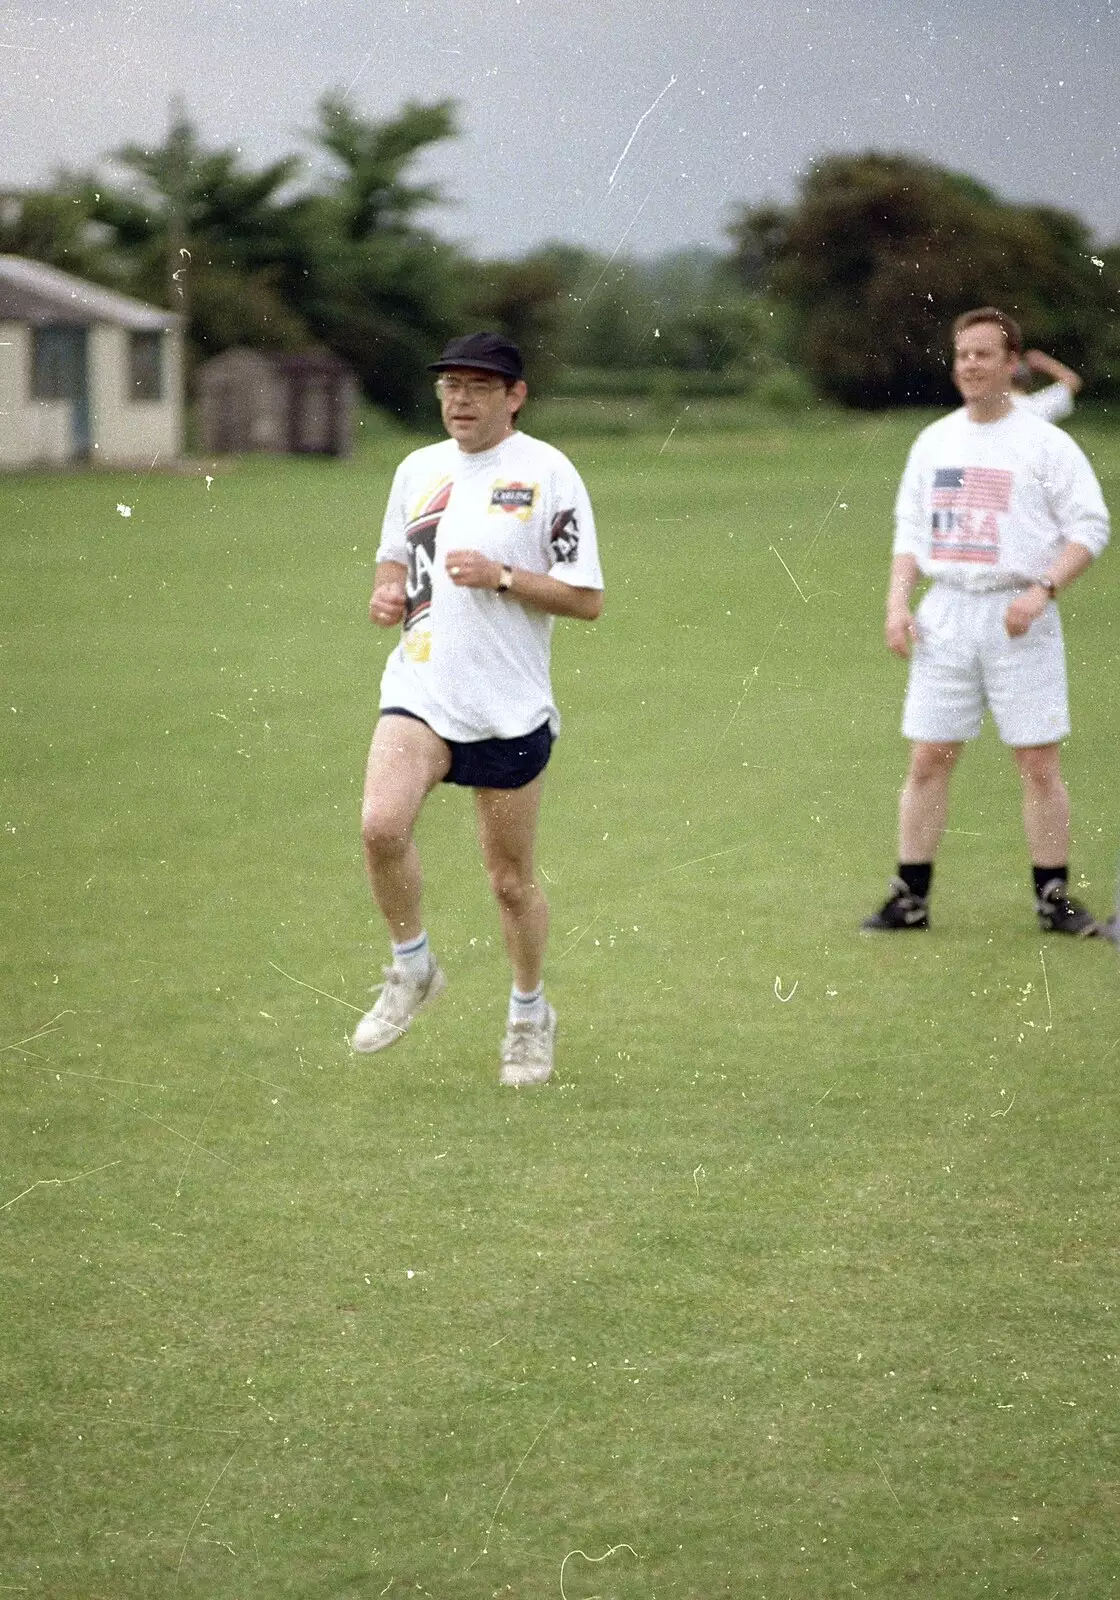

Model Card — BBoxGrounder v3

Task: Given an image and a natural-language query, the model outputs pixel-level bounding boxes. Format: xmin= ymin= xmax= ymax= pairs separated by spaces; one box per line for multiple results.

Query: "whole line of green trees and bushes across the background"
xmin=0 ymin=93 xmax=1120 ymax=414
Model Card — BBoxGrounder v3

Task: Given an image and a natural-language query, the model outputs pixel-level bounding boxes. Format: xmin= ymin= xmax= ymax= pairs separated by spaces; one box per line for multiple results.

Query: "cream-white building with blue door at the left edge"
xmin=0 ymin=256 xmax=182 ymax=467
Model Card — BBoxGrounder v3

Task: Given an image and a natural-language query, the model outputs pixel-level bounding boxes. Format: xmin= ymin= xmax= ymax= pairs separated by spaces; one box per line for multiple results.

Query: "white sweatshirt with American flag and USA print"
xmin=894 ymin=406 xmax=1109 ymax=590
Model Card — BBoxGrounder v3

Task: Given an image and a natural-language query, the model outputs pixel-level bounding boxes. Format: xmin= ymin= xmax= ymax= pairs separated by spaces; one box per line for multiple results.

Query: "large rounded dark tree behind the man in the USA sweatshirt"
xmin=731 ymin=152 xmax=1104 ymax=406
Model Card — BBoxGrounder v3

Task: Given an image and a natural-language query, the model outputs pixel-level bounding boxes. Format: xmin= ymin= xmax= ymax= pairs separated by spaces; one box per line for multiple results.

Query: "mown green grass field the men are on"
xmin=0 ymin=406 xmax=1120 ymax=1600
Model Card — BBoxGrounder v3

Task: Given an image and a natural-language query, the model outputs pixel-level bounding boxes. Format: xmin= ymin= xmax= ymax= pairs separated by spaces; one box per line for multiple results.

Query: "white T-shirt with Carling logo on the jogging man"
xmin=378 ymin=432 xmax=603 ymax=741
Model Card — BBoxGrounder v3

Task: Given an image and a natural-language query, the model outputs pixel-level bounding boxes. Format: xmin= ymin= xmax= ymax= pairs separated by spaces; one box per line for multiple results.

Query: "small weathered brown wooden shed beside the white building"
xmin=195 ymin=349 xmax=357 ymax=456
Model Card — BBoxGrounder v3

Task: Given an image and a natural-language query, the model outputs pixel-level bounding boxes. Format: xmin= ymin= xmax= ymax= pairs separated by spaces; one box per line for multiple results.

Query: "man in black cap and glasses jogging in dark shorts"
xmin=354 ymin=333 xmax=603 ymax=1085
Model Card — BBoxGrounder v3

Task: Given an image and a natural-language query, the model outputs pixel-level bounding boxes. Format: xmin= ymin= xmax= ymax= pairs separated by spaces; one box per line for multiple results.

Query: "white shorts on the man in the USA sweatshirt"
xmin=902 ymin=584 xmax=1069 ymax=749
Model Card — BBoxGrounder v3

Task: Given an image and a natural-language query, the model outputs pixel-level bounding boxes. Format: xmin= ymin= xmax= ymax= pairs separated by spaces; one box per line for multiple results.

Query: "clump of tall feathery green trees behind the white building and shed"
xmin=0 ymin=94 xmax=462 ymax=413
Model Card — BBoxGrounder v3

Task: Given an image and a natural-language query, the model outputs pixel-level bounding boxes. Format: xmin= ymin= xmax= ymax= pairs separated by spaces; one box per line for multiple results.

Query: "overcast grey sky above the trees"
xmin=0 ymin=0 xmax=1120 ymax=256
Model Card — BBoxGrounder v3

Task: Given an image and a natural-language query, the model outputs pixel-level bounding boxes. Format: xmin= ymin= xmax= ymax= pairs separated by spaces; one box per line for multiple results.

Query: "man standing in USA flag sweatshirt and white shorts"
xmin=864 ymin=306 xmax=1109 ymax=936
